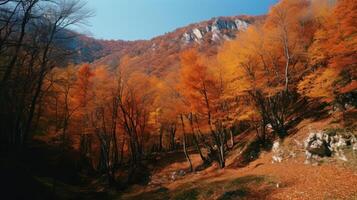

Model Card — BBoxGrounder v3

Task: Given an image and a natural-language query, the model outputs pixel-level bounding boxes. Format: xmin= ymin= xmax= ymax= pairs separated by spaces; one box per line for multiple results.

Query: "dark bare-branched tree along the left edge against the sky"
xmin=0 ymin=0 xmax=92 ymax=149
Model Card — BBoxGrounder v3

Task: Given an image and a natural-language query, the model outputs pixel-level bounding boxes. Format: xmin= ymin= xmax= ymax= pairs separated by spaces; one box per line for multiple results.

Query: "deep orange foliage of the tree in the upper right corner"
xmin=299 ymin=0 xmax=357 ymax=101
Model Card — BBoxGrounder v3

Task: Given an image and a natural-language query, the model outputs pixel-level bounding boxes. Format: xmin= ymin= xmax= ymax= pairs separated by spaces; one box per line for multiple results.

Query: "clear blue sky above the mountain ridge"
xmin=85 ymin=0 xmax=278 ymax=40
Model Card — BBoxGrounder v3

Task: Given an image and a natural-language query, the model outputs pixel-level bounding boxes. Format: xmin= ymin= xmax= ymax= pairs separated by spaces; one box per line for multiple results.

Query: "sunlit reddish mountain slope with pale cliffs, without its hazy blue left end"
xmin=89 ymin=16 xmax=264 ymax=76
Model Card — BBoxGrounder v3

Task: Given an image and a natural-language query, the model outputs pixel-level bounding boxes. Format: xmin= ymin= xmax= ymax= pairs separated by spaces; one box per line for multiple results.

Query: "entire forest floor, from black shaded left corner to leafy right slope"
xmin=0 ymin=111 xmax=357 ymax=200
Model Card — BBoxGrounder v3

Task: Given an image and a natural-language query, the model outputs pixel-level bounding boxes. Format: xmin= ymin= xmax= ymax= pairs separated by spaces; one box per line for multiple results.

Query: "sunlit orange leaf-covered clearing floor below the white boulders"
xmin=119 ymin=149 xmax=357 ymax=200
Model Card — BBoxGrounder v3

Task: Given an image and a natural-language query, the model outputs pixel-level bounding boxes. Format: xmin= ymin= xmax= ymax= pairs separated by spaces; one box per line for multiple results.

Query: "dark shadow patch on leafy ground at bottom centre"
xmin=122 ymin=175 xmax=277 ymax=200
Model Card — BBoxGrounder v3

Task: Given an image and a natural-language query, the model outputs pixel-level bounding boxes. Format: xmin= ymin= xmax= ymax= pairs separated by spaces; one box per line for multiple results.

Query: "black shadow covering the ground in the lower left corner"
xmin=0 ymin=141 xmax=109 ymax=200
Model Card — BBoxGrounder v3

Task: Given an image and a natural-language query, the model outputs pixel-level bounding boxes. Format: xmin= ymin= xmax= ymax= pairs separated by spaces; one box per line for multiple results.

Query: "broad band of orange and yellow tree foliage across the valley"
xmin=35 ymin=0 xmax=357 ymax=170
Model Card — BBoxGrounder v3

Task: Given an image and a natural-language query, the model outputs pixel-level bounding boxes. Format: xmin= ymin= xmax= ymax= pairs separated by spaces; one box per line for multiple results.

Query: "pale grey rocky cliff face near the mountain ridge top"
xmin=181 ymin=18 xmax=250 ymax=44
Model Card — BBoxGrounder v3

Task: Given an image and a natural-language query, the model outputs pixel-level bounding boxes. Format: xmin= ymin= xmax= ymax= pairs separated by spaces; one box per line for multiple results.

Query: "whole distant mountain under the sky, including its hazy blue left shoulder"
xmin=73 ymin=16 xmax=264 ymax=76
